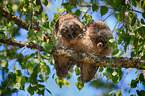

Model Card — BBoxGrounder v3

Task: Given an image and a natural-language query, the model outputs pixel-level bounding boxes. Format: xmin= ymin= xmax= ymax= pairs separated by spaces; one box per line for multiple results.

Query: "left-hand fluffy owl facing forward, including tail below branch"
xmin=53 ymin=14 xmax=83 ymax=78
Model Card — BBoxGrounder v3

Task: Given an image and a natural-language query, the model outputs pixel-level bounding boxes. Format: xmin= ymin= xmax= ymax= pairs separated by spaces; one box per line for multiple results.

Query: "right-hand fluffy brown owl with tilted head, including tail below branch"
xmin=79 ymin=21 xmax=113 ymax=83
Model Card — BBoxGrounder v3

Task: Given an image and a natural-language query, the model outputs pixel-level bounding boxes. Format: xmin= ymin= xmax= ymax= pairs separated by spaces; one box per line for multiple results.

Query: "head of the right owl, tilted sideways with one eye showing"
xmin=85 ymin=21 xmax=113 ymax=56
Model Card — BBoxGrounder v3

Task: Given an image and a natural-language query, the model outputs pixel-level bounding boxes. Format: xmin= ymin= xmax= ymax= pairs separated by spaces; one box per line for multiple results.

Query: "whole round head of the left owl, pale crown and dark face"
xmin=54 ymin=14 xmax=83 ymax=41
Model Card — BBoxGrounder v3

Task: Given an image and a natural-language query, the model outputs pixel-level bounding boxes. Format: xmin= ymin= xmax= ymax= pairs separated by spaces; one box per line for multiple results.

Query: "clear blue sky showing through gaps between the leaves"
xmin=0 ymin=0 xmax=143 ymax=96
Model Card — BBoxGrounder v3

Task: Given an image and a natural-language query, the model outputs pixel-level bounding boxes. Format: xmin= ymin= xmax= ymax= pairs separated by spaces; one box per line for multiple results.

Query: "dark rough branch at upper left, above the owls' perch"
xmin=0 ymin=7 xmax=38 ymax=30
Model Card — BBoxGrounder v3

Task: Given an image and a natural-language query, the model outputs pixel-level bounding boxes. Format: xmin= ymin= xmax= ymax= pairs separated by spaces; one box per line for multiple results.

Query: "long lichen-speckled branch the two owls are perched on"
xmin=0 ymin=38 xmax=145 ymax=69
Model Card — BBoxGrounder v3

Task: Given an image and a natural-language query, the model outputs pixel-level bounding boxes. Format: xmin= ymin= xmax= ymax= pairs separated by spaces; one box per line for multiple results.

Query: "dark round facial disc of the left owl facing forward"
xmin=60 ymin=19 xmax=83 ymax=40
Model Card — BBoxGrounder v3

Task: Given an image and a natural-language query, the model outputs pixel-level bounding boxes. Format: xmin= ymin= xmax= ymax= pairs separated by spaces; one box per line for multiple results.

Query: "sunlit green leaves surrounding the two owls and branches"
xmin=0 ymin=0 xmax=145 ymax=96
